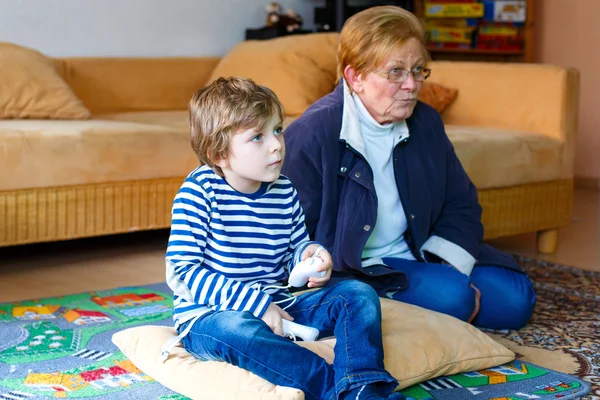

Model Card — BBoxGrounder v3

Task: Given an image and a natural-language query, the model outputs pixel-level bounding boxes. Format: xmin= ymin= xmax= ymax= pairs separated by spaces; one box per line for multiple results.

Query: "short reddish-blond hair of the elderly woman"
xmin=337 ymin=6 xmax=429 ymax=80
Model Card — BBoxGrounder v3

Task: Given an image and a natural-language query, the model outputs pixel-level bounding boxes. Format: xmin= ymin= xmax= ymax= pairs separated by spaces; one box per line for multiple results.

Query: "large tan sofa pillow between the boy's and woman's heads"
xmin=208 ymin=33 xmax=339 ymax=116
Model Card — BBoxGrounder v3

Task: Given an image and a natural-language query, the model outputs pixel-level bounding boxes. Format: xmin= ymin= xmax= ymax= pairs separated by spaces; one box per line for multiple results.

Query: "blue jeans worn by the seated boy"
xmin=179 ymin=280 xmax=398 ymax=399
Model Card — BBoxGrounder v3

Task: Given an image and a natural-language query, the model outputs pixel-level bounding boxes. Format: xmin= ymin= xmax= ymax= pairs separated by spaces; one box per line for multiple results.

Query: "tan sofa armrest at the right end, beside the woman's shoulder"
xmin=431 ymin=61 xmax=579 ymax=176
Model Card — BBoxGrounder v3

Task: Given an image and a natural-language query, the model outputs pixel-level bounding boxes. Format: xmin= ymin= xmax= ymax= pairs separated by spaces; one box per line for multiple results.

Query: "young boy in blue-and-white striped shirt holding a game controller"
xmin=163 ymin=78 xmax=404 ymax=399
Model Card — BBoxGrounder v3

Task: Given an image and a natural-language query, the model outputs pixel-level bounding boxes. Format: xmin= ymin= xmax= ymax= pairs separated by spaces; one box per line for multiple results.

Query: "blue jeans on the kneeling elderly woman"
xmin=383 ymin=258 xmax=536 ymax=329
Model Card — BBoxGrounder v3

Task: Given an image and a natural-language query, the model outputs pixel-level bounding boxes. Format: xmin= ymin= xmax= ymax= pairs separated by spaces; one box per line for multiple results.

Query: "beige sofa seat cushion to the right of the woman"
xmin=446 ymin=125 xmax=568 ymax=189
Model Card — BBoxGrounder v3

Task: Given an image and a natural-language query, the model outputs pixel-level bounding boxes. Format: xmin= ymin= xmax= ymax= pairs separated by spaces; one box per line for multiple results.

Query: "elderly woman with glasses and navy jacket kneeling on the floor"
xmin=282 ymin=6 xmax=535 ymax=329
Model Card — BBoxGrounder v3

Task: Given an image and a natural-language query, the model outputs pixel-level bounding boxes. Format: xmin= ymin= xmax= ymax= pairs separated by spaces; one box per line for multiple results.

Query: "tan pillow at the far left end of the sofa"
xmin=0 ymin=43 xmax=91 ymax=119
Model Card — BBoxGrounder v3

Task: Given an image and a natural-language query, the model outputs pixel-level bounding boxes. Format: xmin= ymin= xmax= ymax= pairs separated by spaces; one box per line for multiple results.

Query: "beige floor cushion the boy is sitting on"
xmin=113 ymin=299 xmax=515 ymax=400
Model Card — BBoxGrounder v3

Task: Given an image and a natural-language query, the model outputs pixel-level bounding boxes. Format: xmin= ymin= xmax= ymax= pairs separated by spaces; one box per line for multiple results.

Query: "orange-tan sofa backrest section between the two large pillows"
xmin=55 ymin=57 xmax=220 ymax=114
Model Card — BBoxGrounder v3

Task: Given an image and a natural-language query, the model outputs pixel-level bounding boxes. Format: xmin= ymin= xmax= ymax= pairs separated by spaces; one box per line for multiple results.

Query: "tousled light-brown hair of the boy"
xmin=189 ymin=77 xmax=285 ymax=175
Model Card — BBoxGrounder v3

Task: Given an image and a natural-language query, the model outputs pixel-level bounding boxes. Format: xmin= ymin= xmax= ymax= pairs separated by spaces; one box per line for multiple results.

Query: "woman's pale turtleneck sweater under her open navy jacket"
xmin=352 ymin=95 xmax=415 ymax=260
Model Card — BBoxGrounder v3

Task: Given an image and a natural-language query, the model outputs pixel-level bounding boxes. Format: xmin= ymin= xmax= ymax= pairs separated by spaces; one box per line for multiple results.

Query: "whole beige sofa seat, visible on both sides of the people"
xmin=0 ymin=111 xmax=565 ymax=194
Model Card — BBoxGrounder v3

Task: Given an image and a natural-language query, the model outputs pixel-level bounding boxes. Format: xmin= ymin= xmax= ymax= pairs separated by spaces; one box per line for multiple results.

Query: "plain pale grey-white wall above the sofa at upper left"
xmin=0 ymin=0 xmax=323 ymax=57
